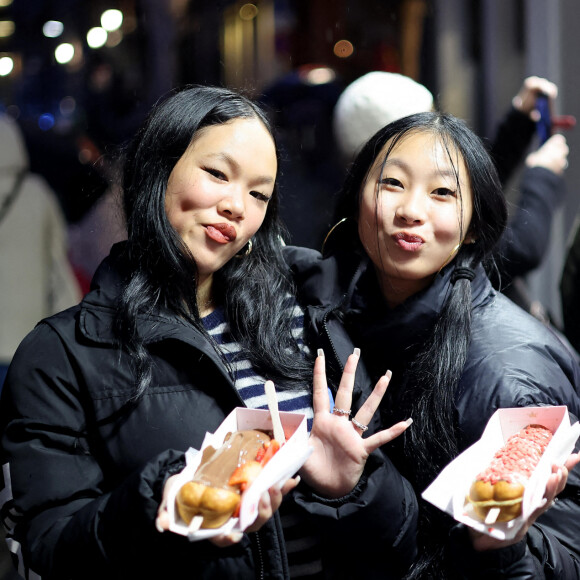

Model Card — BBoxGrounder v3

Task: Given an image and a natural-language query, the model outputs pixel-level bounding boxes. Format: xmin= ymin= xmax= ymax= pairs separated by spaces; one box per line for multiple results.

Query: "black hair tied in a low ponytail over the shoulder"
xmin=328 ymin=112 xmax=507 ymax=578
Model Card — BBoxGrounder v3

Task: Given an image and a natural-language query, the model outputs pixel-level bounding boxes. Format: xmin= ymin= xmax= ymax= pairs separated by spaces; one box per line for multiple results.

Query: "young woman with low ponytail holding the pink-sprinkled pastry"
xmin=286 ymin=113 xmax=580 ymax=579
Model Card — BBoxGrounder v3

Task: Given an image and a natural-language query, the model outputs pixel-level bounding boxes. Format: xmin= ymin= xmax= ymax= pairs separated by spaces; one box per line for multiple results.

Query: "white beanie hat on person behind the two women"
xmin=333 ymin=71 xmax=433 ymax=160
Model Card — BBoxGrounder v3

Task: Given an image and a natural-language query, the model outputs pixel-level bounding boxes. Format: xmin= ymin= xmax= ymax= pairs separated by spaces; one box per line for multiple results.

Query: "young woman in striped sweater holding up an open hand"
xmin=0 ymin=87 xmax=417 ymax=580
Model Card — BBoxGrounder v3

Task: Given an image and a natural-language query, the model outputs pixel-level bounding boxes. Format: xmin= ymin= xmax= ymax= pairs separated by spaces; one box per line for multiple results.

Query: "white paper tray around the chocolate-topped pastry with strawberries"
xmin=167 ymin=407 xmax=312 ymax=541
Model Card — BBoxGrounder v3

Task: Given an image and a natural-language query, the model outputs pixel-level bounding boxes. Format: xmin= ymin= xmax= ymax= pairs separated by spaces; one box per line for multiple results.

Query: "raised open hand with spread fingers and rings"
xmin=300 ymin=349 xmax=412 ymax=498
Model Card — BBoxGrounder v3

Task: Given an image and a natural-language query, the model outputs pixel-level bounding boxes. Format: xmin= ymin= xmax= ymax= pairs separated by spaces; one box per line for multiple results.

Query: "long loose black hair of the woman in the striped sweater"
xmin=116 ymin=86 xmax=311 ymax=398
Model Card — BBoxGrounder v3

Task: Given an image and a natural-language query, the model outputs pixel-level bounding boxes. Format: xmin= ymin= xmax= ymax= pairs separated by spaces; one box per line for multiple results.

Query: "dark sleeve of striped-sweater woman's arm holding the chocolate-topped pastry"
xmin=1 ymin=325 xmax=181 ymax=578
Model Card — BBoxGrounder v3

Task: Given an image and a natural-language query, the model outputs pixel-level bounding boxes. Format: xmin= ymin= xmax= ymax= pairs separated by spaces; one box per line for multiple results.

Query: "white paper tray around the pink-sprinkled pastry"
xmin=422 ymin=406 xmax=580 ymax=540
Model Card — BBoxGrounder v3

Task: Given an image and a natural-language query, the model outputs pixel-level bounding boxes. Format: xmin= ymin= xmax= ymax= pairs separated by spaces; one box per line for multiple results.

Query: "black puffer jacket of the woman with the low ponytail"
xmin=285 ymin=248 xmax=580 ymax=580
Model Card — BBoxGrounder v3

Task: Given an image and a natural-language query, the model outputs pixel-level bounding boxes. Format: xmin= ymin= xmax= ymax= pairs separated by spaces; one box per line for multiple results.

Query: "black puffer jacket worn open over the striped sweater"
xmin=0 ymin=245 xmax=417 ymax=580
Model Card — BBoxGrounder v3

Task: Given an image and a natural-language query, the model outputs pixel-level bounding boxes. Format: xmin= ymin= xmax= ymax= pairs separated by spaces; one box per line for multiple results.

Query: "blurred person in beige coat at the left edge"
xmin=0 ymin=115 xmax=81 ymax=386
